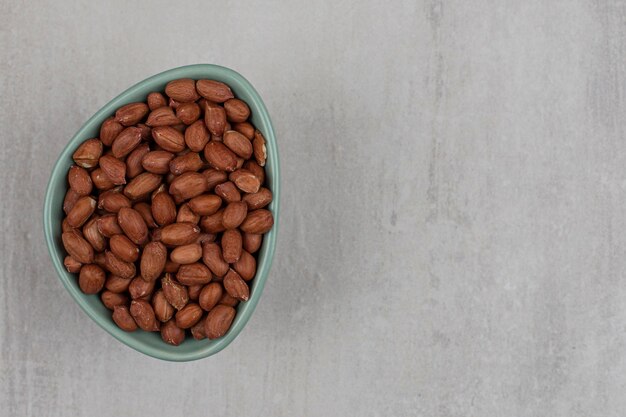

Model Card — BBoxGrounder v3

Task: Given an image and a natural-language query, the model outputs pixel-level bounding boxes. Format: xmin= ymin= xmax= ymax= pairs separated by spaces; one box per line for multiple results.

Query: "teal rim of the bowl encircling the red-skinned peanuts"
xmin=43 ymin=64 xmax=280 ymax=362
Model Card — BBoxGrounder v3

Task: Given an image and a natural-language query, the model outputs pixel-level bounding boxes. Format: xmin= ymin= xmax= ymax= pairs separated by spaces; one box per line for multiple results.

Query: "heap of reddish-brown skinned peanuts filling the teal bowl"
xmin=62 ymin=79 xmax=274 ymax=345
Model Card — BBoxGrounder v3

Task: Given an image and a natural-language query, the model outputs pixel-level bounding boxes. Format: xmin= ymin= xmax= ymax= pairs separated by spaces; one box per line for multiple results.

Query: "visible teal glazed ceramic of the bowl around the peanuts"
xmin=43 ymin=64 xmax=280 ymax=362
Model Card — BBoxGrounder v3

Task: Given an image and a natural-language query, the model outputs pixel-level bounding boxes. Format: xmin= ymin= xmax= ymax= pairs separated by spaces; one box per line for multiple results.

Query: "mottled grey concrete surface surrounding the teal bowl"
xmin=0 ymin=0 xmax=626 ymax=417
